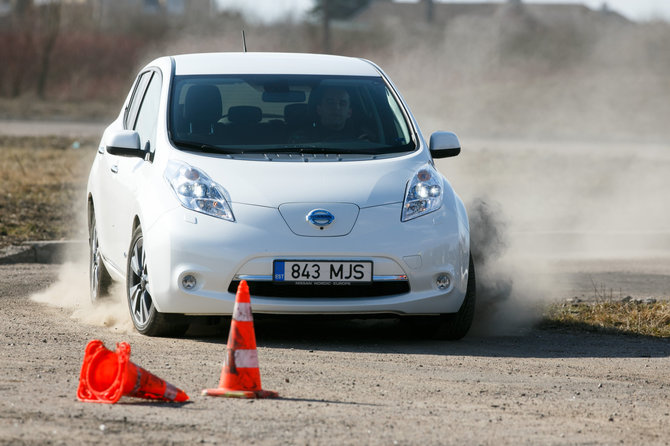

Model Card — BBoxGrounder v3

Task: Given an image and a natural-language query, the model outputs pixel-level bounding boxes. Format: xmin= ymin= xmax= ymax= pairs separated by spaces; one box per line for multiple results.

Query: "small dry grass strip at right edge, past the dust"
xmin=542 ymin=300 xmax=670 ymax=338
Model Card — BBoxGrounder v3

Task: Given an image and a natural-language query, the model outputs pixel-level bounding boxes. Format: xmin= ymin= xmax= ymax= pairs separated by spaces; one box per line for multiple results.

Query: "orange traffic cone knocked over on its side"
xmin=77 ymin=340 xmax=188 ymax=404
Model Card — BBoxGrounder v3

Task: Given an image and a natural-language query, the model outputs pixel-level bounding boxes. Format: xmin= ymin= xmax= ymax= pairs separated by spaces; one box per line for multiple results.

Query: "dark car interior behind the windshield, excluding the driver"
xmin=171 ymin=77 xmax=409 ymax=147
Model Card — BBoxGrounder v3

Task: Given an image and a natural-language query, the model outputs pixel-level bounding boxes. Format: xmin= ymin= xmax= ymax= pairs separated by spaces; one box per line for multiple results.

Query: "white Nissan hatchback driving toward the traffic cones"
xmin=87 ymin=53 xmax=475 ymax=339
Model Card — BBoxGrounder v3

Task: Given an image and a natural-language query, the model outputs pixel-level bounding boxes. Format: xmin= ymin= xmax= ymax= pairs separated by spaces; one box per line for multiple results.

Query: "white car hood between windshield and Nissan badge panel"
xmin=175 ymin=153 xmax=428 ymax=208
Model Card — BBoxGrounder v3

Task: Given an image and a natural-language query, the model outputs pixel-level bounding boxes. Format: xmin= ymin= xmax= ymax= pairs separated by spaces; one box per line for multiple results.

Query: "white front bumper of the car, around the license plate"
xmin=144 ymin=203 xmax=469 ymax=315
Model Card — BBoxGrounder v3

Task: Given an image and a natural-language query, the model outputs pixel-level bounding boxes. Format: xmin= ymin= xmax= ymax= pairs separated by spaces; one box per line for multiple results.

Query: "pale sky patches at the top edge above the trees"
xmin=217 ymin=0 xmax=670 ymax=22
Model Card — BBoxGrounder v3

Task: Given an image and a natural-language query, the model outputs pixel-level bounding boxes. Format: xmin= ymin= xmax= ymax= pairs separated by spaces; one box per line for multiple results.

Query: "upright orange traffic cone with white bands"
xmin=202 ymin=280 xmax=279 ymax=398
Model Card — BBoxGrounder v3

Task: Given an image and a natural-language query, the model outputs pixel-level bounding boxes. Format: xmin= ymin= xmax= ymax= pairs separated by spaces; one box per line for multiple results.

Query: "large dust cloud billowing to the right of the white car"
xmin=418 ymin=7 xmax=670 ymax=334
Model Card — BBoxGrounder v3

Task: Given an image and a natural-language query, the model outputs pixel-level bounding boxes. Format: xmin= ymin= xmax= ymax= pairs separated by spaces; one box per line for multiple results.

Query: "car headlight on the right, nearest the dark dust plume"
xmin=402 ymin=164 xmax=442 ymax=221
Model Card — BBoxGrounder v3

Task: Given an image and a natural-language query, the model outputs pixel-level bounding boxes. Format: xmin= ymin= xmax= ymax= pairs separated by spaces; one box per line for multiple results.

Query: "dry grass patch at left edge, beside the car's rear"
xmin=0 ymin=138 xmax=95 ymax=248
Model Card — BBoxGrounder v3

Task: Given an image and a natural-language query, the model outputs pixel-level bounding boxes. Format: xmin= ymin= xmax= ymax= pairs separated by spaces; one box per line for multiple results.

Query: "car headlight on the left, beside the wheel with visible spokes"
xmin=165 ymin=160 xmax=235 ymax=221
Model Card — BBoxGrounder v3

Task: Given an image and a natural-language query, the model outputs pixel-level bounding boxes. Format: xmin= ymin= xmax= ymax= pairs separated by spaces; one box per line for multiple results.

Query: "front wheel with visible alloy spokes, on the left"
xmin=126 ymin=226 xmax=188 ymax=336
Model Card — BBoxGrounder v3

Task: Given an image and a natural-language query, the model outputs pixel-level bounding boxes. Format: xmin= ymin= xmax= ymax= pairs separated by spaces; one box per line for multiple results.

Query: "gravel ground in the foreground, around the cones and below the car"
xmin=0 ymin=264 xmax=670 ymax=445
